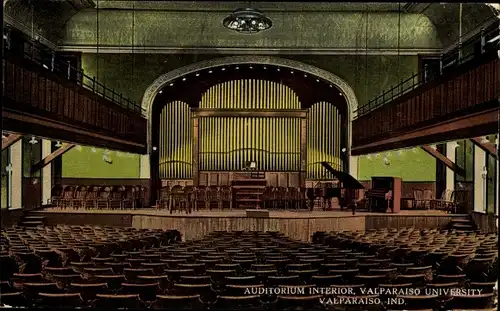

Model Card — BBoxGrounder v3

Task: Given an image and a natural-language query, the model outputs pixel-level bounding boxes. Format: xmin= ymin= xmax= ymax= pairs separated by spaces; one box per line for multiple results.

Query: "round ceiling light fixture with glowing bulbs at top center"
xmin=222 ymin=8 xmax=273 ymax=33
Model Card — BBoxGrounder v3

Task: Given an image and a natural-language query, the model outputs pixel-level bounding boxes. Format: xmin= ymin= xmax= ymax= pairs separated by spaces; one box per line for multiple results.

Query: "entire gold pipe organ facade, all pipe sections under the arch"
xmin=159 ymin=79 xmax=345 ymax=180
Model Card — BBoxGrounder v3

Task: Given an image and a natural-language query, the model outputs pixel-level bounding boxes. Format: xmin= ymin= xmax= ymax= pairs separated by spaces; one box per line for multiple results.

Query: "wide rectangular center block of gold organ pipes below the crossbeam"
xmin=199 ymin=117 xmax=300 ymax=172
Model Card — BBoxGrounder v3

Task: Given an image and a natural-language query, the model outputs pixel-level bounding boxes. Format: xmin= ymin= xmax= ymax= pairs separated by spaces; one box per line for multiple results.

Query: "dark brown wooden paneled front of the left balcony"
xmin=3 ymin=57 xmax=147 ymax=152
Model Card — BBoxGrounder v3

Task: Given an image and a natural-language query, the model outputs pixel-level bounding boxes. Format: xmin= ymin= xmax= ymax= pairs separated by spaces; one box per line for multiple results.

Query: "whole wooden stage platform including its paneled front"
xmin=32 ymin=208 xmax=466 ymax=241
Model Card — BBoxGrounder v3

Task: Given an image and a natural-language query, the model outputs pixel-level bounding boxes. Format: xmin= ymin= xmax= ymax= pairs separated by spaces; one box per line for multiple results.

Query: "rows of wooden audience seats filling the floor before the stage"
xmin=0 ymin=226 xmax=498 ymax=310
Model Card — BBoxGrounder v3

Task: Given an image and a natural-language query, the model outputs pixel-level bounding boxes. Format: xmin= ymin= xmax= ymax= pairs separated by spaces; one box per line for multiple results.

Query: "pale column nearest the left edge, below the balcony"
xmin=10 ymin=139 xmax=23 ymax=208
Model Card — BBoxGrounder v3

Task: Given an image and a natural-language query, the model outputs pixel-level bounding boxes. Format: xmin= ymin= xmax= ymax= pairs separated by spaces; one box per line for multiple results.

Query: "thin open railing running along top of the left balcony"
xmin=5 ymin=35 xmax=145 ymax=115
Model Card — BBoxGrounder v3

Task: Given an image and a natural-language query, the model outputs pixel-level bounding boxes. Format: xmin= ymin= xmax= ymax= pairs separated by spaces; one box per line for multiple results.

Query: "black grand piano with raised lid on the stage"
xmin=306 ymin=162 xmax=364 ymax=210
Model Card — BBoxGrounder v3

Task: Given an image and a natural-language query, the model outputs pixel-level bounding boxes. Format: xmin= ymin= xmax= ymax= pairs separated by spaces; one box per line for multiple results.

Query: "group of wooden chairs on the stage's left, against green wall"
xmin=50 ymin=185 xmax=146 ymax=209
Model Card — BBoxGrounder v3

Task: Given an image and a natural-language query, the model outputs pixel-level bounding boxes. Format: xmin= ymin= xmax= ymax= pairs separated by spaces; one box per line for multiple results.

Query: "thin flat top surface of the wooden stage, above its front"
xmin=34 ymin=207 xmax=461 ymax=219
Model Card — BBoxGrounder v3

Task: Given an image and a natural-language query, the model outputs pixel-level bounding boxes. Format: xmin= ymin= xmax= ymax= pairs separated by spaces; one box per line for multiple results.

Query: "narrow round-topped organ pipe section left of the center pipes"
xmin=159 ymin=101 xmax=193 ymax=179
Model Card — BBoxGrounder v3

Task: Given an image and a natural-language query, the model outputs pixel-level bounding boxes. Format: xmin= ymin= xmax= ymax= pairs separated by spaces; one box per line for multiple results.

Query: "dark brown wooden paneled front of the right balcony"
xmin=352 ymin=51 xmax=500 ymax=148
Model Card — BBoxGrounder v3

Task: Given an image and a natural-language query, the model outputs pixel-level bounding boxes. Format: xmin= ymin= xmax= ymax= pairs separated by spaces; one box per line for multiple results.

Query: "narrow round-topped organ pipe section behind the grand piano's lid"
xmin=306 ymin=102 xmax=345 ymax=179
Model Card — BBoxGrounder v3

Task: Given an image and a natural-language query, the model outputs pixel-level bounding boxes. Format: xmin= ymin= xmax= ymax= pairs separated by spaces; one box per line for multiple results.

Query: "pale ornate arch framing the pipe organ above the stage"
xmin=140 ymin=55 xmax=358 ymax=178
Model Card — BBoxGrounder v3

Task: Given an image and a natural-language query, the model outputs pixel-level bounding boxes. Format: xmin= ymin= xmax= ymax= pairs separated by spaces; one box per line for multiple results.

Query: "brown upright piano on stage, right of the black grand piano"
xmin=365 ymin=177 xmax=402 ymax=213
